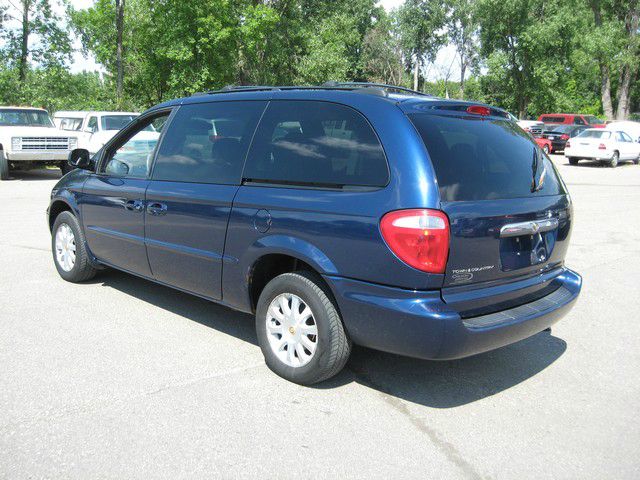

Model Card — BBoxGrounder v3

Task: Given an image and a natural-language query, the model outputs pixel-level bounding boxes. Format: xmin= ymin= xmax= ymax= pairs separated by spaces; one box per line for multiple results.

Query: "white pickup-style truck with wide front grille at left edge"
xmin=0 ymin=107 xmax=78 ymax=180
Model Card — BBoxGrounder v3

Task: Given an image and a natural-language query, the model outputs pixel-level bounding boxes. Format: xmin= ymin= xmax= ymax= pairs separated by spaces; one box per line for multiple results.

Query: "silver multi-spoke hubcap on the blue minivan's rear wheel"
xmin=266 ymin=293 xmax=318 ymax=367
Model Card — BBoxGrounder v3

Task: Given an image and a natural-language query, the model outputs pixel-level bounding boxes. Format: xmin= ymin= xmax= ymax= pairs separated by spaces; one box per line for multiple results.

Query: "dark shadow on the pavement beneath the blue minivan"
xmin=94 ymin=270 xmax=567 ymax=408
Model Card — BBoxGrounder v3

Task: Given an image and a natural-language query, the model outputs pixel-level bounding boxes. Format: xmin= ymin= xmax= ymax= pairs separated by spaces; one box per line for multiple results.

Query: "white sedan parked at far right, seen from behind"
xmin=564 ymin=128 xmax=640 ymax=168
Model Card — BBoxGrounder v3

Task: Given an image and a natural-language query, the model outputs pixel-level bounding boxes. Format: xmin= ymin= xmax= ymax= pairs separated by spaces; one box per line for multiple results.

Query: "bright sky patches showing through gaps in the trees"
xmin=41 ymin=0 xmax=460 ymax=81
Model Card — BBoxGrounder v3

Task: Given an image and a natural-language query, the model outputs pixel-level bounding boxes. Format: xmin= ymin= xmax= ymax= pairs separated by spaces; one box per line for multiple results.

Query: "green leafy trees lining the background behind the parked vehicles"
xmin=0 ymin=0 xmax=640 ymax=117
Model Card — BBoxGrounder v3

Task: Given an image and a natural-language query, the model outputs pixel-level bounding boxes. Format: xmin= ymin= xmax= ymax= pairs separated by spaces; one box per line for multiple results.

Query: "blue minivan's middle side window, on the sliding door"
xmin=153 ymin=101 xmax=266 ymax=185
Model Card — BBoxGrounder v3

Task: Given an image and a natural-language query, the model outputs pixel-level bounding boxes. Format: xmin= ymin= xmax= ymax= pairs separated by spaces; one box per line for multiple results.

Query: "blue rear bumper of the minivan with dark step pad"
xmin=325 ymin=268 xmax=582 ymax=360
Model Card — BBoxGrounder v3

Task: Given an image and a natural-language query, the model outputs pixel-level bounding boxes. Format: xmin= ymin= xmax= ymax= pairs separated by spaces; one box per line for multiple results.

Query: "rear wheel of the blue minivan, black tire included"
xmin=256 ymin=271 xmax=351 ymax=385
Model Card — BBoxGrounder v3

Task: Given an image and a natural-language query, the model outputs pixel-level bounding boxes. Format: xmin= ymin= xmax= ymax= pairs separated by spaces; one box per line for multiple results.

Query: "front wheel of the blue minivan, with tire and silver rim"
xmin=51 ymin=211 xmax=97 ymax=283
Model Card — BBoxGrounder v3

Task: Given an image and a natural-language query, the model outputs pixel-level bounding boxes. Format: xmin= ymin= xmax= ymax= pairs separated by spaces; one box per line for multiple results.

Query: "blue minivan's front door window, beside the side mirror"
xmin=101 ymin=112 xmax=169 ymax=178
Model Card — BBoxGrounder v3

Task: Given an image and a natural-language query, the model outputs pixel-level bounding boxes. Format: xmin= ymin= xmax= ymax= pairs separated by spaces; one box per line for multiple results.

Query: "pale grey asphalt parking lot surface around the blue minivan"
xmin=0 ymin=156 xmax=640 ymax=479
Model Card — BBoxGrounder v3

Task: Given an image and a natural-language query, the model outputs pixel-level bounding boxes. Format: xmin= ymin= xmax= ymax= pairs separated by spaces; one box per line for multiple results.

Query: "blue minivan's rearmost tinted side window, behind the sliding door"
xmin=244 ymin=101 xmax=389 ymax=187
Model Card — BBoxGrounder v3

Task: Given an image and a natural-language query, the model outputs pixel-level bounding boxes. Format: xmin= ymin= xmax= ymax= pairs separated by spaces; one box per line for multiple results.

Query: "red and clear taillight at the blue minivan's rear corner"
xmin=380 ymin=209 xmax=449 ymax=273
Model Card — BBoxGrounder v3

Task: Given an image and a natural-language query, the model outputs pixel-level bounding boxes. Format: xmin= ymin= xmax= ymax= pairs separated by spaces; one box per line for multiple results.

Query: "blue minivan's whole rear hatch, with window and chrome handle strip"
xmin=407 ymin=104 xmax=571 ymax=298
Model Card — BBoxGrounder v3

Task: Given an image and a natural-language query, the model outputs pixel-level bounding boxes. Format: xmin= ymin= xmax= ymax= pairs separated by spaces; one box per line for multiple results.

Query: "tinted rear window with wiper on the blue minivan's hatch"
xmin=409 ymin=113 xmax=564 ymax=202
